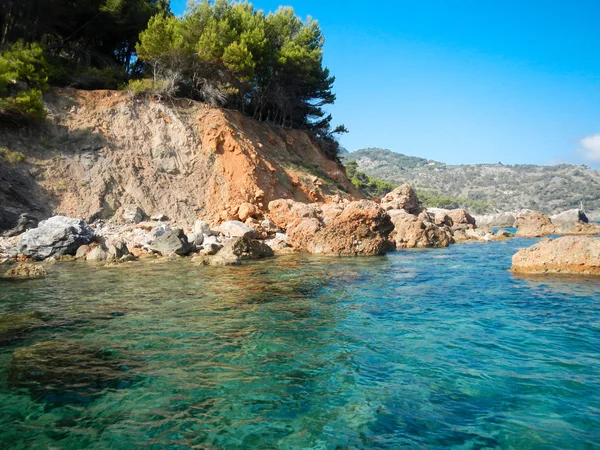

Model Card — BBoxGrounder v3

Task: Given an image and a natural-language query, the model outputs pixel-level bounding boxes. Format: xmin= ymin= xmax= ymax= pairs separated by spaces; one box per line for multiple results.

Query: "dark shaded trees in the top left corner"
xmin=0 ymin=0 xmax=169 ymax=89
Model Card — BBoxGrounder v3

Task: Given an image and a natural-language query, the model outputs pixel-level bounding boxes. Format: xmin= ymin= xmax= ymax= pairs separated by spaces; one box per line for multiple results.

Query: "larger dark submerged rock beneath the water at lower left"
xmin=8 ymin=340 xmax=137 ymax=403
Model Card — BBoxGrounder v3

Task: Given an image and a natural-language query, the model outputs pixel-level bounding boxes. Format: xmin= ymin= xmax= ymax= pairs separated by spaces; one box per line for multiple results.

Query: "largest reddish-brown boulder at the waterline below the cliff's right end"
xmin=304 ymin=200 xmax=394 ymax=256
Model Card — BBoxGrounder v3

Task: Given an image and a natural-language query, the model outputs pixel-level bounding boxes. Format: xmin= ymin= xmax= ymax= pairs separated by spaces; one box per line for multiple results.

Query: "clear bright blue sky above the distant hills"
xmin=172 ymin=0 xmax=600 ymax=166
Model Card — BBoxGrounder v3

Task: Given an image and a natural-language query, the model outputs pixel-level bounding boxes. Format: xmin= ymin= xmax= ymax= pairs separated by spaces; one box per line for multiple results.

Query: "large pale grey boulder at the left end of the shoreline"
xmin=18 ymin=216 xmax=94 ymax=261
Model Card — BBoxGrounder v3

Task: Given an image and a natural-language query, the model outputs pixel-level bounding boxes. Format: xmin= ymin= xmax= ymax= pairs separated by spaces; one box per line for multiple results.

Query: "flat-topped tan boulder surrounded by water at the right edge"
xmin=511 ymin=236 xmax=600 ymax=275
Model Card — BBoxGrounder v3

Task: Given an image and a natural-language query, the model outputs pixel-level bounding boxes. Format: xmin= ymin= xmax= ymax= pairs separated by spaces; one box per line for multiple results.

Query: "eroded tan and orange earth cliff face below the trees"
xmin=0 ymin=89 xmax=361 ymax=229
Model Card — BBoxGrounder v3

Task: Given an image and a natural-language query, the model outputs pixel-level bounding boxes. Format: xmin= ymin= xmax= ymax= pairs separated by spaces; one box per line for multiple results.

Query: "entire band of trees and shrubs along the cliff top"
xmin=0 ymin=0 xmax=347 ymax=157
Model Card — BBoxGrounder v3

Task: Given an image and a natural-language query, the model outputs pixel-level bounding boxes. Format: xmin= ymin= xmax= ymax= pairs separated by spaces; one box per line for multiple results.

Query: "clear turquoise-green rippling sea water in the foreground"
xmin=0 ymin=239 xmax=600 ymax=449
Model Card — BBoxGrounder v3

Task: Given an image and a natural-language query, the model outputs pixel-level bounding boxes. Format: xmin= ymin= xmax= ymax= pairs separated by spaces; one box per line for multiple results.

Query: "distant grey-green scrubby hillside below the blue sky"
xmin=341 ymin=148 xmax=600 ymax=213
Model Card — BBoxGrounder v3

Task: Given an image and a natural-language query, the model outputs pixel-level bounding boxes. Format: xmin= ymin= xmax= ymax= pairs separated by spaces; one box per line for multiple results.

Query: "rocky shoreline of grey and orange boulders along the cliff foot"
xmin=0 ymin=184 xmax=600 ymax=279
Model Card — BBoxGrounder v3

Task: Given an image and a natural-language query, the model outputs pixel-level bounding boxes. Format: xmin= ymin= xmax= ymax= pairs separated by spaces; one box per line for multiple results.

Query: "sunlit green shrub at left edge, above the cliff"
xmin=0 ymin=42 xmax=48 ymax=119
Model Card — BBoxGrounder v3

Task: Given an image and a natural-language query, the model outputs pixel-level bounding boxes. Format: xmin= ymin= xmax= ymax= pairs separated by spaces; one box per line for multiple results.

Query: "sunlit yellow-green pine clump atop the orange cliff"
xmin=137 ymin=0 xmax=347 ymax=153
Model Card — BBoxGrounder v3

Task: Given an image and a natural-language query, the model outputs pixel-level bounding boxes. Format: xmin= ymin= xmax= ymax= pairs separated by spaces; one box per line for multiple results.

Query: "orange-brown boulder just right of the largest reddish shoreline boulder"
xmin=388 ymin=209 xmax=452 ymax=248
